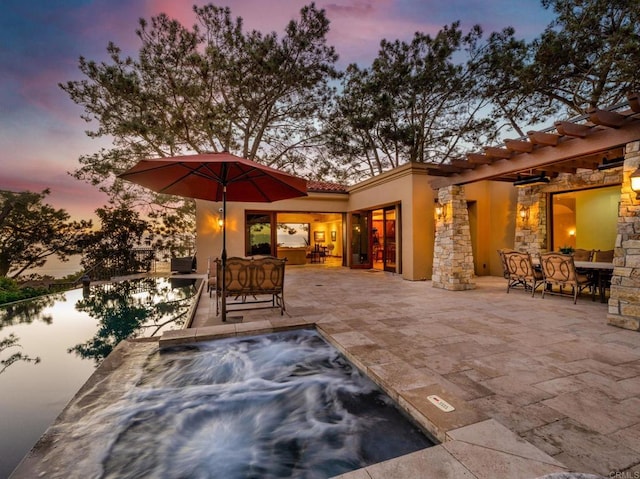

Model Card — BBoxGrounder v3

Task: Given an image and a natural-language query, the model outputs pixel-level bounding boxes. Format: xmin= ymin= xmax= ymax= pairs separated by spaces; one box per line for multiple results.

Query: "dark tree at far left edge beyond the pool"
xmin=0 ymin=189 xmax=92 ymax=278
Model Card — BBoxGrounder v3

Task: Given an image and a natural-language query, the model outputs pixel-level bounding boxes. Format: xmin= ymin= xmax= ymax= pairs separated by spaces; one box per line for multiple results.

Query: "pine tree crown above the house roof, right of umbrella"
xmin=328 ymin=22 xmax=493 ymax=179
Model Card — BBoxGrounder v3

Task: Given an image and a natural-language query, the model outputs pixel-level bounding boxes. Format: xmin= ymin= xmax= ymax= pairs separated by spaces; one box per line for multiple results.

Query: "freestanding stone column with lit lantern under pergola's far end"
xmin=432 ymin=185 xmax=476 ymax=291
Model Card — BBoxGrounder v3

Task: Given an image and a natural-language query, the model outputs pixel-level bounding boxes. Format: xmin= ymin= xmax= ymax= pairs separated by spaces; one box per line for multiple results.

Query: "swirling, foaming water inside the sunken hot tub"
xmin=77 ymin=330 xmax=433 ymax=479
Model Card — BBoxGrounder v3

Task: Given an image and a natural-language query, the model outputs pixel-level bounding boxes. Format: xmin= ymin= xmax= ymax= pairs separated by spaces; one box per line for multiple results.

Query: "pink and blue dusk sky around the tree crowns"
xmin=0 ymin=0 xmax=553 ymax=218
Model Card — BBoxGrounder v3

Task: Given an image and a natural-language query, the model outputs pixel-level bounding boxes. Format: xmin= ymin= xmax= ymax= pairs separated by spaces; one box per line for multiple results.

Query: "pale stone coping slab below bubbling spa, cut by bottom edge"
xmin=362 ymin=446 xmax=475 ymax=479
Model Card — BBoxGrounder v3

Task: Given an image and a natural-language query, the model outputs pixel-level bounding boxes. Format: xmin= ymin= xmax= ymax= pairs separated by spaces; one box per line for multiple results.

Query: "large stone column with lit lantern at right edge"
xmin=607 ymin=141 xmax=640 ymax=331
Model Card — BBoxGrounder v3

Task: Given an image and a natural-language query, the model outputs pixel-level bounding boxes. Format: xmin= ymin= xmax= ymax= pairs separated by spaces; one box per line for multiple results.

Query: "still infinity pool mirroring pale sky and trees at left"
xmin=0 ymin=278 xmax=198 ymax=477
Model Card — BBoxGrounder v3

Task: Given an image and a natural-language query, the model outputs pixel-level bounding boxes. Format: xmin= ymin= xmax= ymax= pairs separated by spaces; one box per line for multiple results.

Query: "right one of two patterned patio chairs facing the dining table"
xmin=540 ymin=253 xmax=595 ymax=304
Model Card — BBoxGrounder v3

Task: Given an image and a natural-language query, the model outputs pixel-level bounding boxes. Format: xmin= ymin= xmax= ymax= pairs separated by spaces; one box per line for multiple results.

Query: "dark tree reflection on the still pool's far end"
xmin=68 ymin=278 xmax=196 ymax=362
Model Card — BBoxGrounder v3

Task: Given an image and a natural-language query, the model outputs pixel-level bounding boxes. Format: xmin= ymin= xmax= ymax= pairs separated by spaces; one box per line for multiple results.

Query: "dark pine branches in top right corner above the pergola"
xmin=483 ymin=0 xmax=640 ymax=135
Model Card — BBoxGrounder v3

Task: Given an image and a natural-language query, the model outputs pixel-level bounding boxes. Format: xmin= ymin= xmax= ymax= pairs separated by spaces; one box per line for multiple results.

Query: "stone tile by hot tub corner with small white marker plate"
xmin=398 ymin=384 xmax=487 ymax=442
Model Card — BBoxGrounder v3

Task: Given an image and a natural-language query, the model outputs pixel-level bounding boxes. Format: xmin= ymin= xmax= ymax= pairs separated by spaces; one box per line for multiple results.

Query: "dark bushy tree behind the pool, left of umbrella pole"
xmin=82 ymin=205 xmax=149 ymax=277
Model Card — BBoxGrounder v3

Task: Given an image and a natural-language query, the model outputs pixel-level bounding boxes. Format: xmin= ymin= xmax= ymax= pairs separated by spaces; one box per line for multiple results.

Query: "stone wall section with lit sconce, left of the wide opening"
xmin=513 ymin=186 xmax=547 ymax=255
